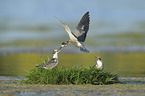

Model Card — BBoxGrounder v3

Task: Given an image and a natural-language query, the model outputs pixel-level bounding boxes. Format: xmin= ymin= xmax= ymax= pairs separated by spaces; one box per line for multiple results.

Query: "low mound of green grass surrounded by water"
xmin=23 ymin=67 xmax=118 ymax=85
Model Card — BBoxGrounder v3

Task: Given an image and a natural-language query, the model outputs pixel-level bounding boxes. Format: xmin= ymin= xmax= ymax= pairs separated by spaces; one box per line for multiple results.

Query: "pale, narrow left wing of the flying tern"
xmin=56 ymin=18 xmax=77 ymax=41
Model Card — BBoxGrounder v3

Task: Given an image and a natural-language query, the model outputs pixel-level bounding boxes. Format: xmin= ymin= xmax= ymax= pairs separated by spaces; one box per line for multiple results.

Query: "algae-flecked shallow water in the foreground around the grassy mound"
xmin=0 ymin=76 xmax=145 ymax=96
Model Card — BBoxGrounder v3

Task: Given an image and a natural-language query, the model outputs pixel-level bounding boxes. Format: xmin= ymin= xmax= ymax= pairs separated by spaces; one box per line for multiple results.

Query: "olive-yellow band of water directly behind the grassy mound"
xmin=0 ymin=52 xmax=145 ymax=77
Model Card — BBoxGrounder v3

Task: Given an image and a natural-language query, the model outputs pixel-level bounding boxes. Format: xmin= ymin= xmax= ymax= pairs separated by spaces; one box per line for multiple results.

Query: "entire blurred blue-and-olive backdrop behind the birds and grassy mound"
xmin=0 ymin=0 xmax=145 ymax=76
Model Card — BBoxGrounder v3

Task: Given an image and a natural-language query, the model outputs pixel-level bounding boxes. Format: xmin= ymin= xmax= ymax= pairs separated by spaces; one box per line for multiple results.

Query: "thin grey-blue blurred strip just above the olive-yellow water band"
xmin=0 ymin=46 xmax=145 ymax=56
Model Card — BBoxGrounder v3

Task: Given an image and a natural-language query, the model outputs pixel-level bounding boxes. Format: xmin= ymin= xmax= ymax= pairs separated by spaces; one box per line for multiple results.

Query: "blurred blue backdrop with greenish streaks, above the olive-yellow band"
xmin=0 ymin=0 xmax=145 ymax=55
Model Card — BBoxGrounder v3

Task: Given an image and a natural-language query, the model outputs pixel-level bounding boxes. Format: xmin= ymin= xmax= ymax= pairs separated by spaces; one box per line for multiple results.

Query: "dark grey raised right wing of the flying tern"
xmin=75 ymin=12 xmax=90 ymax=42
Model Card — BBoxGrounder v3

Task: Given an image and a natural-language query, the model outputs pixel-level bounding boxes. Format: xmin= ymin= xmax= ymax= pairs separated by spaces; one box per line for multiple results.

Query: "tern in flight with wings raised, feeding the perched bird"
xmin=56 ymin=12 xmax=90 ymax=53
